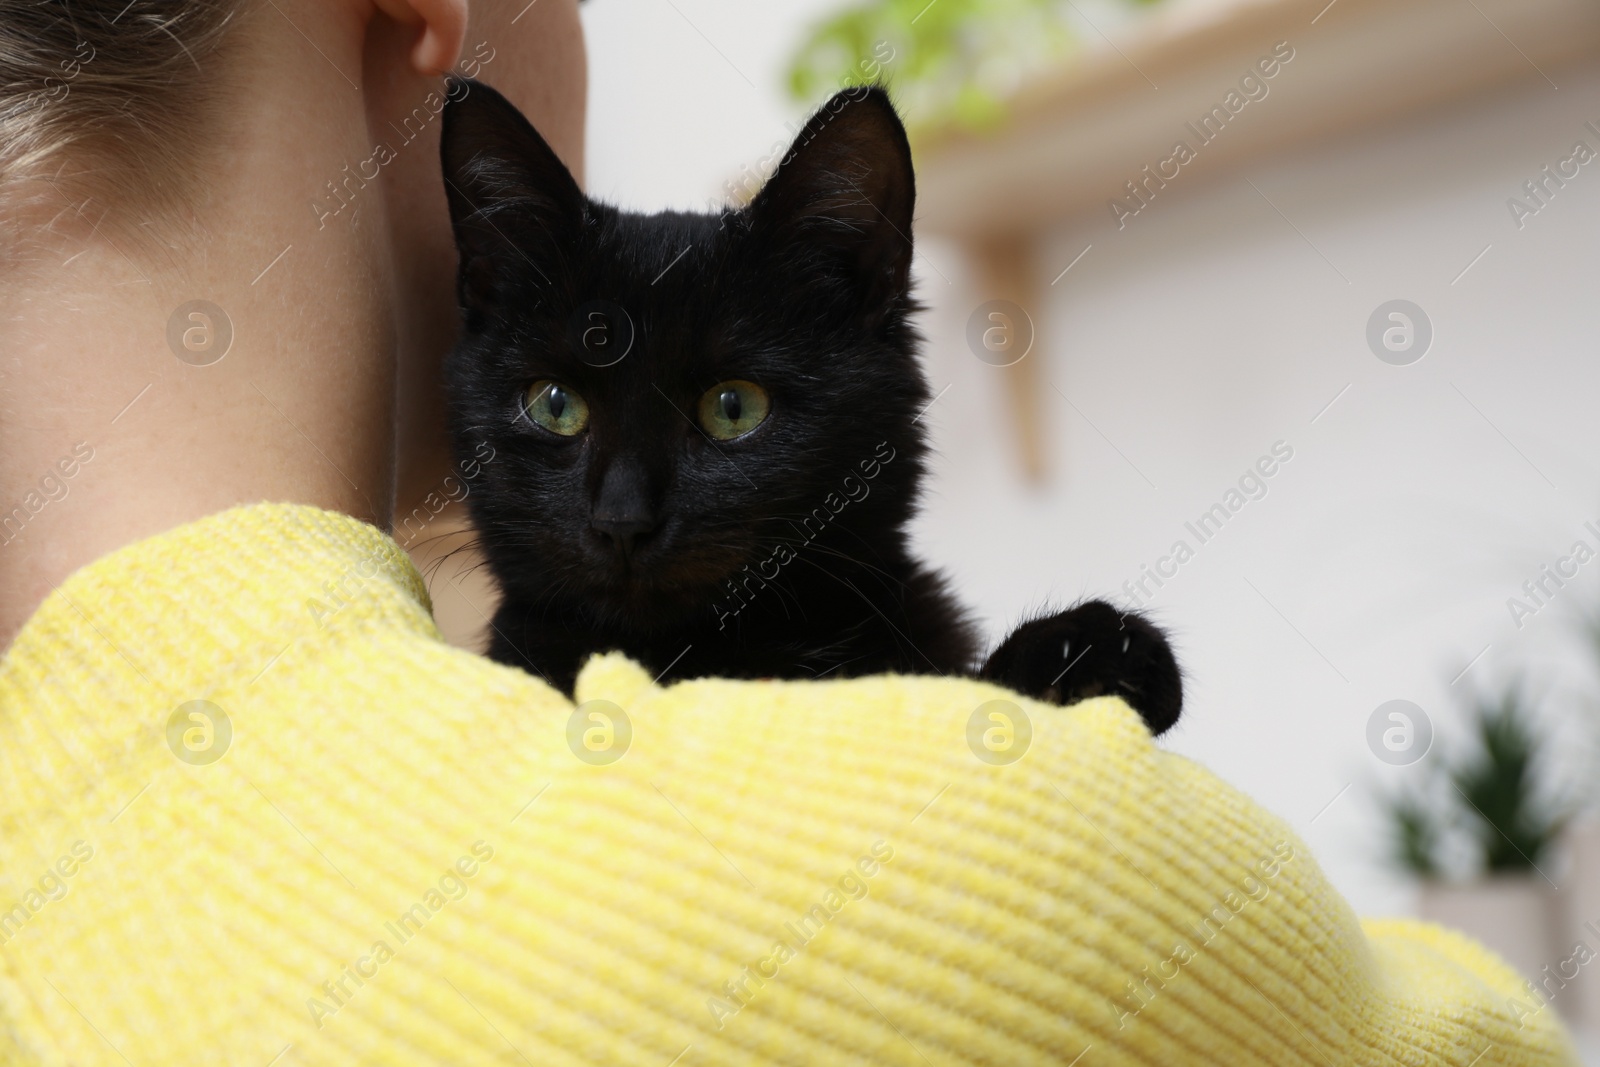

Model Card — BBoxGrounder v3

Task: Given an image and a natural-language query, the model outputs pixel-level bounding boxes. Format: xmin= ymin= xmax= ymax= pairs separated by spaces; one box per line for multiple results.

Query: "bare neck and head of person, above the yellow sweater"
xmin=0 ymin=0 xmax=586 ymax=633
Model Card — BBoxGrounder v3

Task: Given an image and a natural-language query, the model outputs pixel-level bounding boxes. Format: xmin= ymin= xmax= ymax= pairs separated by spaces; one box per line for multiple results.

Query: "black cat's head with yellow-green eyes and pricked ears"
xmin=442 ymin=83 xmax=928 ymax=629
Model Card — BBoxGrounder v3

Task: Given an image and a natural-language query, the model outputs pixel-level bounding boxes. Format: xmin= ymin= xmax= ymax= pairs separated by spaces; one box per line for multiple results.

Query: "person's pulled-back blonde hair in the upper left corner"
xmin=0 ymin=0 xmax=246 ymax=235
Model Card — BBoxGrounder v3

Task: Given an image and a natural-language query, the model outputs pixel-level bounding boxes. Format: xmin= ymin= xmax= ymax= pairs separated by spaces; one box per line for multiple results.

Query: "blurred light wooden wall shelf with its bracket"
xmin=914 ymin=0 xmax=1600 ymax=480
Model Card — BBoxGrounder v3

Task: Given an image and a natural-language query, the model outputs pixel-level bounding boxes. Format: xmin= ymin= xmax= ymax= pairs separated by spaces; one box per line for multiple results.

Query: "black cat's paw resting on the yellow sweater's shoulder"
xmin=979 ymin=600 xmax=1184 ymax=734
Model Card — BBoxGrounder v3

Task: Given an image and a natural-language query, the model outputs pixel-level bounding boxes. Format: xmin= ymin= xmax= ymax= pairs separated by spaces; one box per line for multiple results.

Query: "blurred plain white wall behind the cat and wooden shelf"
xmin=584 ymin=0 xmax=1600 ymax=913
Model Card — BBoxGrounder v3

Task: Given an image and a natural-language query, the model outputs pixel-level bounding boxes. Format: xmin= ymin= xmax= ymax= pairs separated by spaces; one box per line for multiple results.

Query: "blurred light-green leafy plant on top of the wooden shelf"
xmin=789 ymin=0 xmax=1160 ymax=128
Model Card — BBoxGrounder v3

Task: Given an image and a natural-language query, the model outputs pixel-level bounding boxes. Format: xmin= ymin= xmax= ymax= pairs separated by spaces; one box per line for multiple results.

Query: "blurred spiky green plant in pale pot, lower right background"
xmin=1382 ymin=685 xmax=1568 ymax=979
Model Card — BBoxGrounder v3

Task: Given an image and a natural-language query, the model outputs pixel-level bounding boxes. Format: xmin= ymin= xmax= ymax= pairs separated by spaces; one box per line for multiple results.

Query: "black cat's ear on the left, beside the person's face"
xmin=440 ymin=78 xmax=586 ymax=323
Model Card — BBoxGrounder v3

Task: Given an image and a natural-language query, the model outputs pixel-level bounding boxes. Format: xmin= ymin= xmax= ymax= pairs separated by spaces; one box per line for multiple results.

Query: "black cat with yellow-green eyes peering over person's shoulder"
xmin=442 ymin=85 xmax=1182 ymax=733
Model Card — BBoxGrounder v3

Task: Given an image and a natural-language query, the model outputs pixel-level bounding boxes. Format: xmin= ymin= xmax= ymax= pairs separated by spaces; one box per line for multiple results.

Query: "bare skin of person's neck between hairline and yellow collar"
xmin=0 ymin=5 xmax=395 ymax=648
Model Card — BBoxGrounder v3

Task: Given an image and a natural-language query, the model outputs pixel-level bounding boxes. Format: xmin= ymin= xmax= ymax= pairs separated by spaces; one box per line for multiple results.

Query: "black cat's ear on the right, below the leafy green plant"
xmin=750 ymin=85 xmax=917 ymax=322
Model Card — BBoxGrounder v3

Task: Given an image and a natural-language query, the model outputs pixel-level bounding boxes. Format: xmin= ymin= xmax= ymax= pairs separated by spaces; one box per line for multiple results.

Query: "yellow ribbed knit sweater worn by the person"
xmin=0 ymin=506 xmax=1574 ymax=1067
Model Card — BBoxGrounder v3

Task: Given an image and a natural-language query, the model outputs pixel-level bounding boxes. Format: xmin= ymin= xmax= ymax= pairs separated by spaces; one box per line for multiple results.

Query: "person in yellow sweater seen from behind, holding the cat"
xmin=0 ymin=0 xmax=1573 ymax=1067
